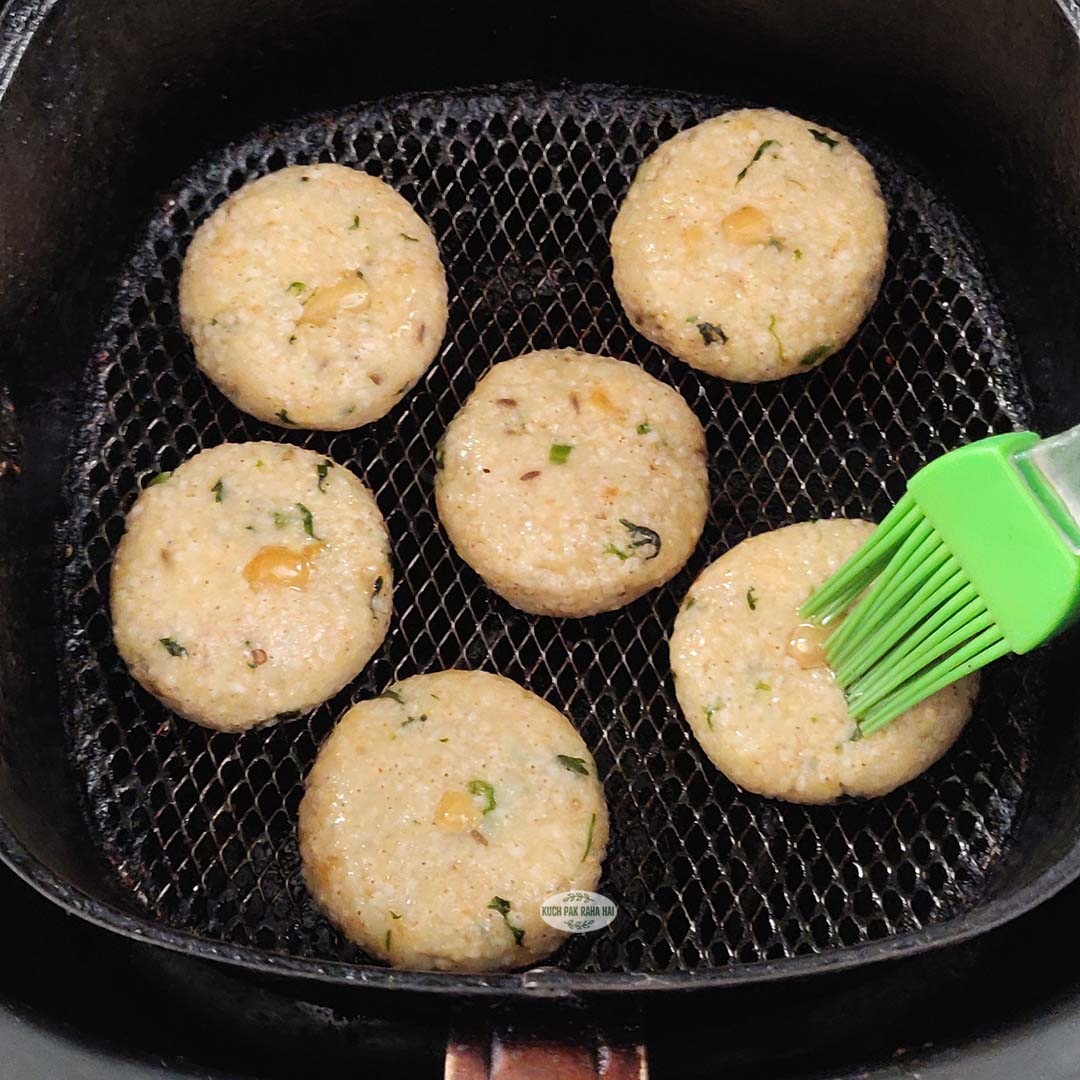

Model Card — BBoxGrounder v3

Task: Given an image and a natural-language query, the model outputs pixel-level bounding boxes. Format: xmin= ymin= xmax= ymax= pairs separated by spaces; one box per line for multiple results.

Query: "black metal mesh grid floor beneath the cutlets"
xmin=65 ymin=87 xmax=1039 ymax=973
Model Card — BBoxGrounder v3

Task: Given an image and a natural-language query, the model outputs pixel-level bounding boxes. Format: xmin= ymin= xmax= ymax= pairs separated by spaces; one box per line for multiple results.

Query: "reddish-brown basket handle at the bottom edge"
xmin=444 ymin=1017 xmax=649 ymax=1080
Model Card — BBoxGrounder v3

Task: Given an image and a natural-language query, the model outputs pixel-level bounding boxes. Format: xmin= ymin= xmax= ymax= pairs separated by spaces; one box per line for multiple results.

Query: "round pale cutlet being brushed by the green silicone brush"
xmin=671 ymin=521 xmax=978 ymax=802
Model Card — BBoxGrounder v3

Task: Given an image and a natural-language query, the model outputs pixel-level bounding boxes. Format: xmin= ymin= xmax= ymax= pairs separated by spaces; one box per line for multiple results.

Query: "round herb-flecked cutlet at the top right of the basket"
xmin=611 ymin=109 xmax=888 ymax=382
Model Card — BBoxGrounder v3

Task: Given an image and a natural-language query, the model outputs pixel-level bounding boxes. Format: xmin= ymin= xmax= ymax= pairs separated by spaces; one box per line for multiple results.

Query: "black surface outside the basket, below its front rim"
xmin=10 ymin=812 xmax=1080 ymax=1080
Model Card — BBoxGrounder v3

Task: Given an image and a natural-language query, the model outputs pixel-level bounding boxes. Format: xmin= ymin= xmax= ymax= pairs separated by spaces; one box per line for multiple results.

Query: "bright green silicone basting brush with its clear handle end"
xmin=800 ymin=427 xmax=1080 ymax=735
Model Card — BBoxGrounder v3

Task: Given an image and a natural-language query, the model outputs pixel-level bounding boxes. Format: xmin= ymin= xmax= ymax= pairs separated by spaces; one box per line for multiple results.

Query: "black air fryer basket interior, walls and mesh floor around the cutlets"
xmin=0 ymin=0 xmax=1080 ymax=990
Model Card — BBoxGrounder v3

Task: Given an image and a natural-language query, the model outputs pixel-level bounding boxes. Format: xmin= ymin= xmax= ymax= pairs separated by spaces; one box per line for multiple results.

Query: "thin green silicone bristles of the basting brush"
xmin=801 ymin=495 xmax=1009 ymax=735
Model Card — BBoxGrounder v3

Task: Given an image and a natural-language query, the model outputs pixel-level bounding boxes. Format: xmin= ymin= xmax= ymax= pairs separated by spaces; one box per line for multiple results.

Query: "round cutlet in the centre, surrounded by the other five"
xmin=435 ymin=350 xmax=708 ymax=616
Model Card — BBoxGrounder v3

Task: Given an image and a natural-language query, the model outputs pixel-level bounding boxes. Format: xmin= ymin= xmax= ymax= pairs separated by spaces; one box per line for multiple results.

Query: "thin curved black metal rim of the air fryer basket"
xmin=6 ymin=0 xmax=1080 ymax=996
